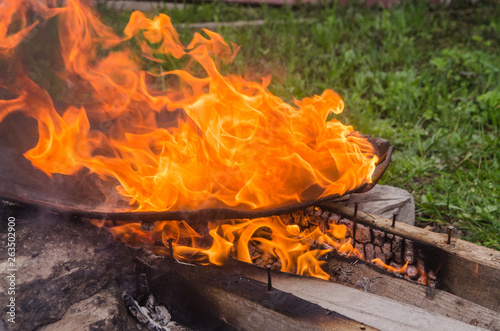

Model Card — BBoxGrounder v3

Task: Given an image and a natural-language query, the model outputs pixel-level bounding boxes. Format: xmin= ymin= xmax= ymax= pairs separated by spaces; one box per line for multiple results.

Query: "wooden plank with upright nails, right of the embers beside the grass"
xmin=320 ymin=202 xmax=500 ymax=312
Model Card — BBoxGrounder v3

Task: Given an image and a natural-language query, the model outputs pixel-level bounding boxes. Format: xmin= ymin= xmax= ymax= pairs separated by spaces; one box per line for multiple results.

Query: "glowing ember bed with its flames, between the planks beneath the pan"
xmin=94 ymin=207 xmax=437 ymax=287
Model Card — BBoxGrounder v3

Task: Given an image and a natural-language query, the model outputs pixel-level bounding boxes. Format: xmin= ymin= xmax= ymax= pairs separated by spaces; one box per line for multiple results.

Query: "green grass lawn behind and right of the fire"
xmin=97 ymin=1 xmax=500 ymax=249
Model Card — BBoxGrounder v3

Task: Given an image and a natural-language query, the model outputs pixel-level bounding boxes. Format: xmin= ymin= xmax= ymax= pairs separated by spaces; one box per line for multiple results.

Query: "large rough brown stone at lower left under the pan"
xmin=0 ymin=211 xmax=137 ymax=331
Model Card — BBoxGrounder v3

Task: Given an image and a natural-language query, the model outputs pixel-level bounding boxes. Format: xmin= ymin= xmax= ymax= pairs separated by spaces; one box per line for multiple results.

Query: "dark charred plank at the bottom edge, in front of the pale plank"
xmin=137 ymin=257 xmax=375 ymax=331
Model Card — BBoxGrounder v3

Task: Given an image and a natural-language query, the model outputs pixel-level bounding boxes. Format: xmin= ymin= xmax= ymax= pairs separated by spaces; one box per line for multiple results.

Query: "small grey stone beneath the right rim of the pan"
xmin=347 ymin=185 xmax=415 ymax=225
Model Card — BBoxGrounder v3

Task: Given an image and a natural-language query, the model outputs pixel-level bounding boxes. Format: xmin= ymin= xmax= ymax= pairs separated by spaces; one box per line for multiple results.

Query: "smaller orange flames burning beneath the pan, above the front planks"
xmin=94 ymin=216 xmax=361 ymax=280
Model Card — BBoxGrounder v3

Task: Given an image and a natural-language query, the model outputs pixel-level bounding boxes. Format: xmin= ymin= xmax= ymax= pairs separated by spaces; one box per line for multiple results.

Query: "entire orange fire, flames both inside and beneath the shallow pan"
xmin=0 ymin=0 xmax=378 ymax=278
